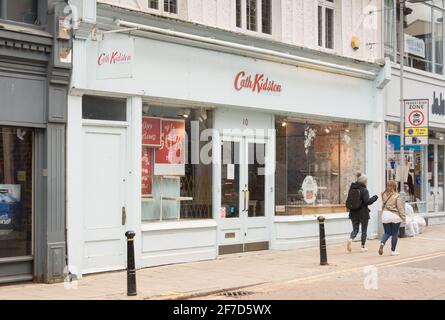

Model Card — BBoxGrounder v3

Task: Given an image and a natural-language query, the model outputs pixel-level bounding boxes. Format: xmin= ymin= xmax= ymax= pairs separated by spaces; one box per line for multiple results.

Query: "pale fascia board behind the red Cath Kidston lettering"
xmin=73 ymin=38 xmax=379 ymax=121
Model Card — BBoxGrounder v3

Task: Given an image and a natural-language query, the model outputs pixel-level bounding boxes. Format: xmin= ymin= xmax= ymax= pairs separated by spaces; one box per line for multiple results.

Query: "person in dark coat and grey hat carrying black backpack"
xmin=346 ymin=173 xmax=379 ymax=252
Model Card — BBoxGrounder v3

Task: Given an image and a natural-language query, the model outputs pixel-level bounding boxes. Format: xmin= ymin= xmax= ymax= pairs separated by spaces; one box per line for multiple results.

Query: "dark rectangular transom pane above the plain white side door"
xmin=82 ymin=96 xmax=127 ymax=121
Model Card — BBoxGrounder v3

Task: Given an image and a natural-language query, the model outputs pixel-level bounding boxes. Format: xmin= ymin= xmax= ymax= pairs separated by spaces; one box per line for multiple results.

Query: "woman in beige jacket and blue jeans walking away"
xmin=379 ymin=180 xmax=406 ymax=256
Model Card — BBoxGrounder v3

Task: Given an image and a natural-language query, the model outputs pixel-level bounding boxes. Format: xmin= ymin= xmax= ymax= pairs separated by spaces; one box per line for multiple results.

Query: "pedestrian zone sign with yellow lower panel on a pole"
xmin=404 ymin=99 xmax=429 ymax=146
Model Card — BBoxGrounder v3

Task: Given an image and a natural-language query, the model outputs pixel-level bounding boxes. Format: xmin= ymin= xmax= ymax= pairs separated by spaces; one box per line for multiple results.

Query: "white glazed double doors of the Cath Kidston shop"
xmin=218 ymin=137 xmax=272 ymax=254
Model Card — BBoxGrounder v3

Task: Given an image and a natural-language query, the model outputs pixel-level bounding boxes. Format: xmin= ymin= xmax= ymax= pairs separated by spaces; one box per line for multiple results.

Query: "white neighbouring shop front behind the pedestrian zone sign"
xmin=385 ymin=68 xmax=445 ymax=225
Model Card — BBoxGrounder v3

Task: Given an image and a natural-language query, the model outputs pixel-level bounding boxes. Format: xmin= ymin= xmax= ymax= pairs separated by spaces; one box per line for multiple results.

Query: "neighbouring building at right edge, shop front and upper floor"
xmin=382 ymin=0 xmax=445 ymax=225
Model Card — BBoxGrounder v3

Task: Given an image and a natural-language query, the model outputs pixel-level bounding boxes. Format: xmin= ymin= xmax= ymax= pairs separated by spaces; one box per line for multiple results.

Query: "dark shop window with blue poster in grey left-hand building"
xmin=0 ymin=127 xmax=33 ymax=259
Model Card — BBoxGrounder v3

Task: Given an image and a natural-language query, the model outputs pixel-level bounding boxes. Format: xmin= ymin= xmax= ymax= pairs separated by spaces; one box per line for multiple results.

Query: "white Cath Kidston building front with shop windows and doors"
xmin=67 ymin=0 xmax=390 ymax=277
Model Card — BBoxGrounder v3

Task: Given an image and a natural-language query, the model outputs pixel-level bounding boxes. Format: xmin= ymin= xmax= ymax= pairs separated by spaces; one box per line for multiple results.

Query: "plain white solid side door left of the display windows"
xmin=82 ymin=126 xmax=128 ymax=274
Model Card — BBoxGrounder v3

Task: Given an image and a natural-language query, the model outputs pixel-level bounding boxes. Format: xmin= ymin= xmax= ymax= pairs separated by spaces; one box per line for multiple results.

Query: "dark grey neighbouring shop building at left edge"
xmin=0 ymin=0 xmax=71 ymax=283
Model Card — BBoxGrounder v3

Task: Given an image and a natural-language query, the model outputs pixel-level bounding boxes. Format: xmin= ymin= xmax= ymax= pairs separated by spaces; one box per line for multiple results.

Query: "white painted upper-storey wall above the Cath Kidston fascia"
xmin=97 ymin=0 xmax=382 ymax=61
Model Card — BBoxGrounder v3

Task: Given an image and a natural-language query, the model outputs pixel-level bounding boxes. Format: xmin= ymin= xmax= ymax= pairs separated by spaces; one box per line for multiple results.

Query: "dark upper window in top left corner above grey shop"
xmin=0 ymin=0 xmax=39 ymax=24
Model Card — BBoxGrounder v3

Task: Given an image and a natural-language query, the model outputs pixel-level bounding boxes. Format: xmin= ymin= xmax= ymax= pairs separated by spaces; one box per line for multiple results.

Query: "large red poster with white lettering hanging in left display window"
xmin=154 ymin=119 xmax=185 ymax=176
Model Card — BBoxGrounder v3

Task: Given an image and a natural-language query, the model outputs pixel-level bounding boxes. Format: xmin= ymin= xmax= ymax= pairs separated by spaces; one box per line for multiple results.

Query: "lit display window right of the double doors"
xmin=275 ymin=121 xmax=365 ymax=215
